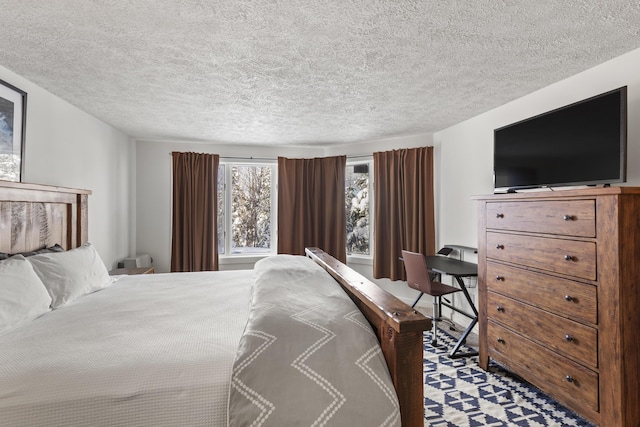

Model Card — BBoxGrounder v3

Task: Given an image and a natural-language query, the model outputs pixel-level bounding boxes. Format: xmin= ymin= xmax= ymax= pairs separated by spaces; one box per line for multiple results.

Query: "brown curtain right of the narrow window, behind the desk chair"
xmin=373 ymin=147 xmax=436 ymax=280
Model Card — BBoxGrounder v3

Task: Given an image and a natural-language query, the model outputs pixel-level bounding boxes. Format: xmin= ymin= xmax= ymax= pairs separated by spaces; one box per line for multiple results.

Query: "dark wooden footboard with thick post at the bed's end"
xmin=305 ymin=248 xmax=431 ymax=427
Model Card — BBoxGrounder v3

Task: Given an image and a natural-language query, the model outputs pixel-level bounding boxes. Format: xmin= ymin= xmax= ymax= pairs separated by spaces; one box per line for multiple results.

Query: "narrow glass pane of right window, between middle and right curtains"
xmin=344 ymin=163 xmax=369 ymax=255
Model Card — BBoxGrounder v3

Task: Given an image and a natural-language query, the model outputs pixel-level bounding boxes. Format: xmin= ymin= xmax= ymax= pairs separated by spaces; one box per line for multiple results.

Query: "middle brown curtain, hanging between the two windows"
xmin=278 ymin=156 xmax=347 ymax=262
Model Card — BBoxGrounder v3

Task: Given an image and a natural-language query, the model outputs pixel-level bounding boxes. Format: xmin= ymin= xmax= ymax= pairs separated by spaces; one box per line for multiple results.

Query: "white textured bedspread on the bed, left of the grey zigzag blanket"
xmin=0 ymin=270 xmax=252 ymax=427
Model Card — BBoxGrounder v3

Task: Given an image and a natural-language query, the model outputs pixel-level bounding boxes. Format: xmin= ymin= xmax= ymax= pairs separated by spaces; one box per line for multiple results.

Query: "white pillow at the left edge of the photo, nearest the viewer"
xmin=0 ymin=255 xmax=51 ymax=334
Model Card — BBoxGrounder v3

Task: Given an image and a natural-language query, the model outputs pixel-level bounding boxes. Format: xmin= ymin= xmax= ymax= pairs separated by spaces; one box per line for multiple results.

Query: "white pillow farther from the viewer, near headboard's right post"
xmin=27 ymin=243 xmax=112 ymax=309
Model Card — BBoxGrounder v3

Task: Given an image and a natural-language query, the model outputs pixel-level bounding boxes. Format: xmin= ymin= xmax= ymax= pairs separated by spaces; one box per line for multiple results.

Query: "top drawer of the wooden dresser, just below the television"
xmin=487 ymin=200 xmax=596 ymax=237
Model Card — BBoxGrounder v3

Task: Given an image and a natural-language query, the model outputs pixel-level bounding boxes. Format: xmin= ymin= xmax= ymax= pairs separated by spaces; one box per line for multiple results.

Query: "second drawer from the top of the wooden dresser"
xmin=486 ymin=232 xmax=596 ymax=280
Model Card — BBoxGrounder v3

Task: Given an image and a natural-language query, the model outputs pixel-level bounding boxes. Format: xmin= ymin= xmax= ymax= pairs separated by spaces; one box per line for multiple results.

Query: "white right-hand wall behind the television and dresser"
xmin=434 ymin=49 xmax=640 ymax=324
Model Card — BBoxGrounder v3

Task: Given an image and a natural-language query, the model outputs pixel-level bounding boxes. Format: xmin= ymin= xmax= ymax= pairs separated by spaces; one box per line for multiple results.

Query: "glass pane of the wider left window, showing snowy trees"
xmin=231 ymin=165 xmax=271 ymax=254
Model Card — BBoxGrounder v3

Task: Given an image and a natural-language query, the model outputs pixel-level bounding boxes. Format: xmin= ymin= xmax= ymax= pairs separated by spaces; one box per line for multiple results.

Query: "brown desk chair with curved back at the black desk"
xmin=402 ymin=250 xmax=461 ymax=347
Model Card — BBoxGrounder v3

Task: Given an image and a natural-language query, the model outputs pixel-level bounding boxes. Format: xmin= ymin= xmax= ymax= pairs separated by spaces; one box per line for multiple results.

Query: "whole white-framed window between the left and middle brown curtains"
xmin=218 ymin=163 xmax=275 ymax=255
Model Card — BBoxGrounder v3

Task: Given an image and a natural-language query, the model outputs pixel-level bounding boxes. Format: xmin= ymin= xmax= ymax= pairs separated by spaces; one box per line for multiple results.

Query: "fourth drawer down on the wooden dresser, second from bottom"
xmin=487 ymin=292 xmax=598 ymax=369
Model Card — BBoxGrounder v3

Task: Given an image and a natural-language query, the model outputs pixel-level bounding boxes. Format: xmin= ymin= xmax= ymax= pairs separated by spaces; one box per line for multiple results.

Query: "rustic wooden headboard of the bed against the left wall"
xmin=0 ymin=181 xmax=91 ymax=253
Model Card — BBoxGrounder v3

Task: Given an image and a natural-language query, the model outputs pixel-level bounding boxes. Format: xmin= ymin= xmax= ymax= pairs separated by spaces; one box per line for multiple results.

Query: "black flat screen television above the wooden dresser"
xmin=493 ymin=86 xmax=627 ymax=192
